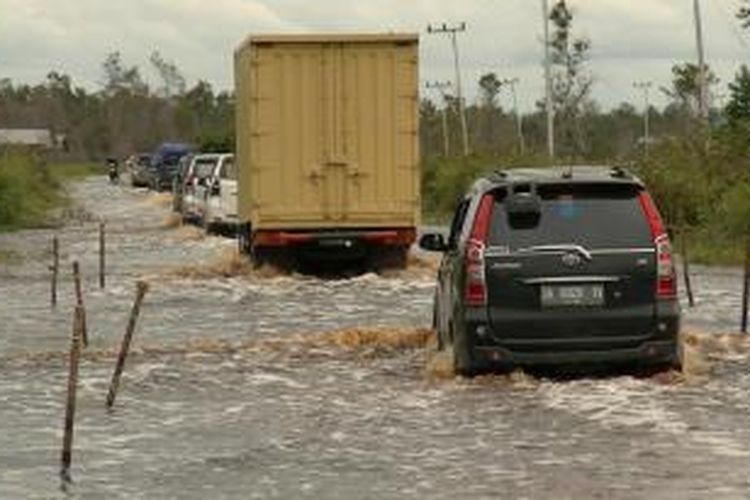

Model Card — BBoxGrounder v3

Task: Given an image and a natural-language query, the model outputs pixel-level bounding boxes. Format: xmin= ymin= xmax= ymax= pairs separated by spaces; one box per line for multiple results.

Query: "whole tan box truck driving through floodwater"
xmin=235 ymin=33 xmax=421 ymax=267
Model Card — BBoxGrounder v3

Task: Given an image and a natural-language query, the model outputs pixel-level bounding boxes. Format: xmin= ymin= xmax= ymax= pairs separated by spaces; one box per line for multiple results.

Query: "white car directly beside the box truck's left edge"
xmin=203 ymin=154 xmax=239 ymax=233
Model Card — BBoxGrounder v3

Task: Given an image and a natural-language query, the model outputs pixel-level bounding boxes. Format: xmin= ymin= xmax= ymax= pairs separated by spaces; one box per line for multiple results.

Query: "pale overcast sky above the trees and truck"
xmin=0 ymin=0 xmax=750 ymax=109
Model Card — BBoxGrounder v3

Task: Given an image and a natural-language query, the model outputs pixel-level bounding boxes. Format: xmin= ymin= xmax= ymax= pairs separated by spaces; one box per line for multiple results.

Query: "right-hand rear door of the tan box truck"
xmin=342 ymin=44 xmax=418 ymax=220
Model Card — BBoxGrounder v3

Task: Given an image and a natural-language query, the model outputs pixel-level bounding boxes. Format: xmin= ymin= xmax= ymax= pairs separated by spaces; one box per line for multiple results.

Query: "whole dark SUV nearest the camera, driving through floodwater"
xmin=420 ymin=167 xmax=681 ymax=374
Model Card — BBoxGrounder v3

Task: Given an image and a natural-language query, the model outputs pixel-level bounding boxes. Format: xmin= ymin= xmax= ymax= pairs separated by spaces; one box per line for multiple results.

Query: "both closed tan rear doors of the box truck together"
xmin=248 ymin=38 xmax=419 ymax=228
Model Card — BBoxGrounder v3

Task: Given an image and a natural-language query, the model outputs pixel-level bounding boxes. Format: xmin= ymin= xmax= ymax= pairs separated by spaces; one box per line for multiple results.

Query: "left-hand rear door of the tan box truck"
xmin=248 ymin=43 xmax=332 ymax=227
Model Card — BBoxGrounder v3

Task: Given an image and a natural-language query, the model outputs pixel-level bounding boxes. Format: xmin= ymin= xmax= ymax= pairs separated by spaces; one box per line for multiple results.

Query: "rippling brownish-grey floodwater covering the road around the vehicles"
xmin=0 ymin=179 xmax=750 ymax=499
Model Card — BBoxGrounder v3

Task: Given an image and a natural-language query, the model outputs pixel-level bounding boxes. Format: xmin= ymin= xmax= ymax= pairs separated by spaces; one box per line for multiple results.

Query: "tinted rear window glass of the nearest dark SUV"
xmin=489 ymin=184 xmax=653 ymax=251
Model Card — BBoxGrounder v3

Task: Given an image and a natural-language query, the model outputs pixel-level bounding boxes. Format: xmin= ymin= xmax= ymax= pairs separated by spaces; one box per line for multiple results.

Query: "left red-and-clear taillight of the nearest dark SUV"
xmin=464 ymin=194 xmax=494 ymax=307
